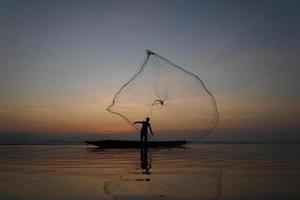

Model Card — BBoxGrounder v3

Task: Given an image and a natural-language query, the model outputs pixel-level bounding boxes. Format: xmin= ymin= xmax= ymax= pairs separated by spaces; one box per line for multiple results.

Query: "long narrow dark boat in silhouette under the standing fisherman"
xmin=85 ymin=140 xmax=188 ymax=149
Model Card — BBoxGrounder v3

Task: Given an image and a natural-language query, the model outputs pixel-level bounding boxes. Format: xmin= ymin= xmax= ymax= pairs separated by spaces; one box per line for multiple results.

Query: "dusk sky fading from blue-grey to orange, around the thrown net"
xmin=0 ymin=0 xmax=300 ymax=141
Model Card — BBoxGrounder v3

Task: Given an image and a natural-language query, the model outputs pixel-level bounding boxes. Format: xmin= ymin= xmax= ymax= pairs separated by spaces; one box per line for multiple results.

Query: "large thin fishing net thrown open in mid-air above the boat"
xmin=107 ymin=50 xmax=219 ymax=140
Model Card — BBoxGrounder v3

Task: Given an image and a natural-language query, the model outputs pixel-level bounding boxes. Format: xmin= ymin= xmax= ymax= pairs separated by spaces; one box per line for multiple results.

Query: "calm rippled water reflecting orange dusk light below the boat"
xmin=0 ymin=144 xmax=300 ymax=200
